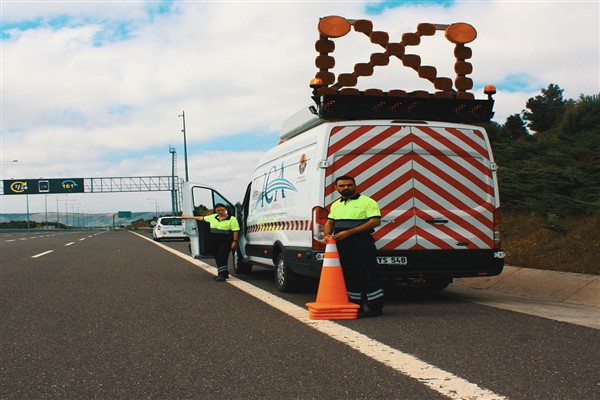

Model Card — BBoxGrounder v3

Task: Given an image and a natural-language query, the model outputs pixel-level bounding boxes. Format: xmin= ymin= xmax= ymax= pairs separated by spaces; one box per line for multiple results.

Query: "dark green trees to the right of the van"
xmin=483 ymin=84 xmax=600 ymax=218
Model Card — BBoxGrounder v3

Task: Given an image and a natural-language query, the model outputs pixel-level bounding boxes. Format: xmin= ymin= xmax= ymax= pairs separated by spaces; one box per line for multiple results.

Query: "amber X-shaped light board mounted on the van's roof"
xmin=310 ymin=16 xmax=496 ymax=123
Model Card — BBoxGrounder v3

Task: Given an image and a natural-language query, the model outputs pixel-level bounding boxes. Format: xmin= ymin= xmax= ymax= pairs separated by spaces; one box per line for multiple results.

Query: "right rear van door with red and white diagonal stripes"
xmin=411 ymin=127 xmax=496 ymax=250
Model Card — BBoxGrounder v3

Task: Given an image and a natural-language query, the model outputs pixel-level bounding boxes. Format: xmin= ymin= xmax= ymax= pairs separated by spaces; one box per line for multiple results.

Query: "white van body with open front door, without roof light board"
xmin=184 ymin=98 xmax=504 ymax=291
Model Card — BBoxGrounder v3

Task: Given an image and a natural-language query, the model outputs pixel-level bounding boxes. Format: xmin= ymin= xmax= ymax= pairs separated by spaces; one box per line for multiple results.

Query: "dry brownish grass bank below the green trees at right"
xmin=501 ymin=211 xmax=600 ymax=275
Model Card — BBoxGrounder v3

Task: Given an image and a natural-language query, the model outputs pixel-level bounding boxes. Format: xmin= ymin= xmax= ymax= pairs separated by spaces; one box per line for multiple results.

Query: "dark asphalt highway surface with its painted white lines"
xmin=0 ymin=231 xmax=600 ymax=400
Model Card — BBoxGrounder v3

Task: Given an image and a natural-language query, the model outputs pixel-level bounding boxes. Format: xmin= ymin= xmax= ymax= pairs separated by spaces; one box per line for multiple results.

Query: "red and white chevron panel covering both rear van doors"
xmin=325 ymin=126 xmax=495 ymax=250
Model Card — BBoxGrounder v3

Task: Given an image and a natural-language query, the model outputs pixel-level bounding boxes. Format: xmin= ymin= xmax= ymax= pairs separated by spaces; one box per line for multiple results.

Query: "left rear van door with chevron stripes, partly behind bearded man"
xmin=325 ymin=125 xmax=416 ymax=250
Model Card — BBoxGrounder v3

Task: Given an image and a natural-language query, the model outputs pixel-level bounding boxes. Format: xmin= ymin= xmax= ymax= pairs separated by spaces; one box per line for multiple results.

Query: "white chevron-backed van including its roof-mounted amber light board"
xmin=184 ymin=16 xmax=504 ymax=291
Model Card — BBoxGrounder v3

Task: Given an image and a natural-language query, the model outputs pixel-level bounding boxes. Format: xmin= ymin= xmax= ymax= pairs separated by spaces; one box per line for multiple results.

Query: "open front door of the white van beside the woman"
xmin=183 ymin=182 xmax=235 ymax=258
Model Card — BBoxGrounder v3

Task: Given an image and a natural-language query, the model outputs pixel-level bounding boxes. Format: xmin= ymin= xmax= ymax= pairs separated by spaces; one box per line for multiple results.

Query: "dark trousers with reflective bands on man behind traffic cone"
xmin=336 ymin=233 xmax=383 ymax=310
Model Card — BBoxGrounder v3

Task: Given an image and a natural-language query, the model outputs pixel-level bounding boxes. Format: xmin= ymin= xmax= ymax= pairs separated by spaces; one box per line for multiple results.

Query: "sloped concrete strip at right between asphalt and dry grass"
xmin=454 ymin=266 xmax=600 ymax=308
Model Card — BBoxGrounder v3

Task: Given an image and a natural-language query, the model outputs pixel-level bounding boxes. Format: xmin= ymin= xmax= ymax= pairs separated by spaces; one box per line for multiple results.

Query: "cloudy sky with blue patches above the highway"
xmin=0 ymin=0 xmax=600 ymax=217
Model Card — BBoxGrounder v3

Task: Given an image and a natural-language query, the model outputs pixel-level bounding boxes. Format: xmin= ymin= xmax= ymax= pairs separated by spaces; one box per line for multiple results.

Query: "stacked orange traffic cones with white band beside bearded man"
xmin=306 ymin=239 xmax=360 ymax=319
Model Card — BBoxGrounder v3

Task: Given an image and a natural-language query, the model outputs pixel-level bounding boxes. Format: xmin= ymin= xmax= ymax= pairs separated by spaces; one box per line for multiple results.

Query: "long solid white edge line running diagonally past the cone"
xmin=132 ymin=232 xmax=506 ymax=400
